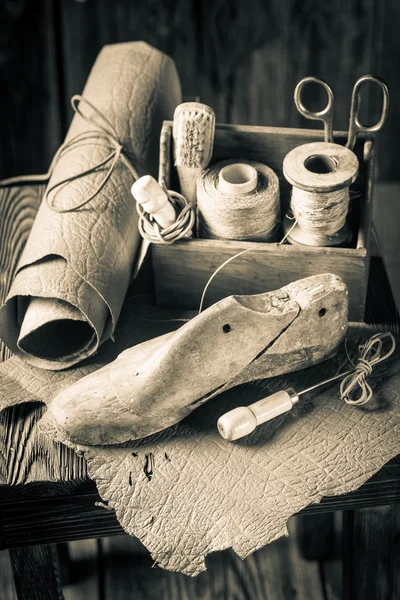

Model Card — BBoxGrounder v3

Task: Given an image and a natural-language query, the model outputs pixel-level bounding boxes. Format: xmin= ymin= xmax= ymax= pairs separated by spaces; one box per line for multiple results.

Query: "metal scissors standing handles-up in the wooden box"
xmin=294 ymin=75 xmax=389 ymax=150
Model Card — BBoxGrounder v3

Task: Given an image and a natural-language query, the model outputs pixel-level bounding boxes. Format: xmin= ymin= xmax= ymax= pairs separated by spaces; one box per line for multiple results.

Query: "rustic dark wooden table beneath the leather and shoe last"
xmin=0 ymin=186 xmax=400 ymax=600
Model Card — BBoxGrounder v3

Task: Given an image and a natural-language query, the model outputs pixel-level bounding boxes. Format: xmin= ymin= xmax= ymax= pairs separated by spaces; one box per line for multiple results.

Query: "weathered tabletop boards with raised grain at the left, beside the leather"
xmin=0 ymin=185 xmax=86 ymax=484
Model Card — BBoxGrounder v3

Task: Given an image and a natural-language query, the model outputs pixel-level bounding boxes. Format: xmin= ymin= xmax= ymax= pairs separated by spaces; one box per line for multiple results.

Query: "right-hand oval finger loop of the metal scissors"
xmin=346 ymin=75 xmax=389 ymax=150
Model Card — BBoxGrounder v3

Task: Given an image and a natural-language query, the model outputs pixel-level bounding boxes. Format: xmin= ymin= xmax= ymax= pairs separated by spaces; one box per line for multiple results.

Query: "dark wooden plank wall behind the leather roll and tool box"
xmin=0 ymin=0 xmax=400 ymax=180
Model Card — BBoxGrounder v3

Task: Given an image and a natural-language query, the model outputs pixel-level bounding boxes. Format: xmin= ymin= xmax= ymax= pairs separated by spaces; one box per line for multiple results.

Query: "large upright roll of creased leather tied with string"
xmin=0 ymin=42 xmax=181 ymax=369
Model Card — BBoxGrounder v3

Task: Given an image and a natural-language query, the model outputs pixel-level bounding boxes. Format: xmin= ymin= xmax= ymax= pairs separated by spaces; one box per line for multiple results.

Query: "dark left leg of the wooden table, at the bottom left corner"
xmin=10 ymin=546 xmax=64 ymax=600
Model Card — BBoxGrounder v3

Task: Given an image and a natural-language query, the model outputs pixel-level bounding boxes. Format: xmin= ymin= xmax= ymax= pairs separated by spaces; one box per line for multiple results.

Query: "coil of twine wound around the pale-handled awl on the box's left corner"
xmin=136 ymin=182 xmax=196 ymax=245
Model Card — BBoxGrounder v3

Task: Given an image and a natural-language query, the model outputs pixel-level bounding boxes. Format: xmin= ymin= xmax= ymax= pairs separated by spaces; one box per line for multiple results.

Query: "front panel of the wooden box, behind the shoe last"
xmin=152 ymin=240 xmax=366 ymax=321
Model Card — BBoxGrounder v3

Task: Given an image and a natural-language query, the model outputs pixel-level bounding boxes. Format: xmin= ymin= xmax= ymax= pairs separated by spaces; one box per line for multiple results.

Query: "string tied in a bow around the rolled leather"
xmin=0 ymin=94 xmax=139 ymax=213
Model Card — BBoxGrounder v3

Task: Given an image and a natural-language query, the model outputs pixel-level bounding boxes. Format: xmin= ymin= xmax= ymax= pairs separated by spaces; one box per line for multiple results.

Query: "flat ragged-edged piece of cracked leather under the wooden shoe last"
xmin=0 ymin=298 xmax=400 ymax=575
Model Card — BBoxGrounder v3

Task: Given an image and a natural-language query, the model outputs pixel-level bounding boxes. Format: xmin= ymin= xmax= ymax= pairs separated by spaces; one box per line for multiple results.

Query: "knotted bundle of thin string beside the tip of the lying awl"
xmin=340 ymin=332 xmax=396 ymax=406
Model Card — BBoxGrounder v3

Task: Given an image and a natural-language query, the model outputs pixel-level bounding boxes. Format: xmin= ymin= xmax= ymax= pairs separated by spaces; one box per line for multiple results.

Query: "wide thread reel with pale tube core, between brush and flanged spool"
xmin=197 ymin=160 xmax=281 ymax=242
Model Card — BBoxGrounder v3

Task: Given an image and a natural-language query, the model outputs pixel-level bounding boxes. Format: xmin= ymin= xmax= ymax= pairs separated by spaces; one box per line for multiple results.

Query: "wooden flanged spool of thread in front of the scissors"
xmin=283 ymin=142 xmax=358 ymax=246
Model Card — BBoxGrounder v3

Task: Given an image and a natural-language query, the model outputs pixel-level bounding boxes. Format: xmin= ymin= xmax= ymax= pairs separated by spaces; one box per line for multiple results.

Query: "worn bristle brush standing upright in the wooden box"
xmin=172 ymin=102 xmax=215 ymax=205
